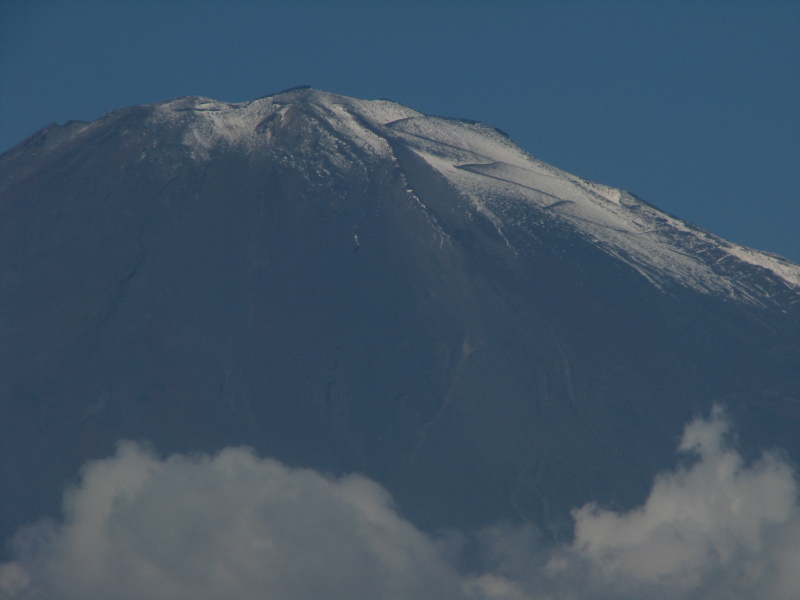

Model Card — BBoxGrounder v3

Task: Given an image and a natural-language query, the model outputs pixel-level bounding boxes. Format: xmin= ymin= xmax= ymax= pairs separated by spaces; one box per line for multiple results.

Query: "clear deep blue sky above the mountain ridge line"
xmin=0 ymin=0 xmax=800 ymax=262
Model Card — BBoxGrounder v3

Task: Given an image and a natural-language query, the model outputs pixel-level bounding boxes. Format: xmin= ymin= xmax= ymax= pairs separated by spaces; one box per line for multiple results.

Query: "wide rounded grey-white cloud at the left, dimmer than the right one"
xmin=0 ymin=443 xmax=461 ymax=600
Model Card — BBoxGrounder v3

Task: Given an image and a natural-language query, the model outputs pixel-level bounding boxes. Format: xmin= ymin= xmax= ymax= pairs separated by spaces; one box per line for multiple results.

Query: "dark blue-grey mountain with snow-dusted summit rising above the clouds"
xmin=0 ymin=88 xmax=800 ymax=536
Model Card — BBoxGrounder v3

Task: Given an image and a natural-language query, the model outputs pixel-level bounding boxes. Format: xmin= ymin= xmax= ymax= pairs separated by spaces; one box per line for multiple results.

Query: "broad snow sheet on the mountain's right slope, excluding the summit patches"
xmin=380 ymin=117 xmax=800 ymax=304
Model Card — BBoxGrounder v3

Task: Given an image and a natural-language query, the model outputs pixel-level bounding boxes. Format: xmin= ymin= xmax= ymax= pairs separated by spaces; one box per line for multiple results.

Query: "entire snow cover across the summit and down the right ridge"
xmin=104 ymin=88 xmax=800 ymax=305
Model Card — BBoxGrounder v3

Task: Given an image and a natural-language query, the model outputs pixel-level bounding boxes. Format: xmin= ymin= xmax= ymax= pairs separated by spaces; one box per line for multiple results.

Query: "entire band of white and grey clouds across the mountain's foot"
xmin=0 ymin=409 xmax=800 ymax=600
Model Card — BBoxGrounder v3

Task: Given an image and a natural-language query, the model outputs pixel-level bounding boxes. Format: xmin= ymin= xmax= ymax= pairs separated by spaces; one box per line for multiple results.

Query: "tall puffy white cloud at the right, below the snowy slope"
xmin=482 ymin=408 xmax=800 ymax=600
